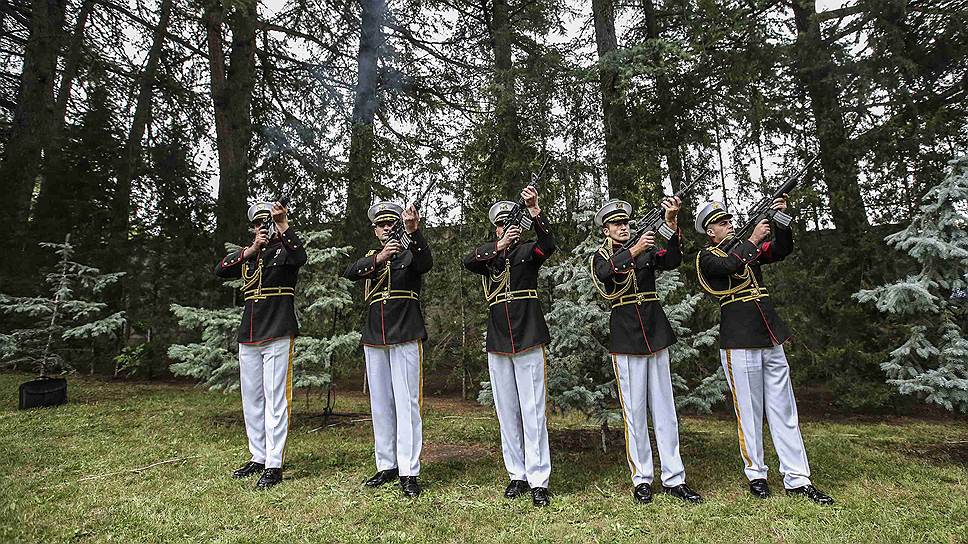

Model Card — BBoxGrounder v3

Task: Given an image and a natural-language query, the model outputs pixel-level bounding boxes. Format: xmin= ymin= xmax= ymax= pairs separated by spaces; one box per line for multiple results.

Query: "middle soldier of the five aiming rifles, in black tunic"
xmin=464 ymin=186 xmax=555 ymax=506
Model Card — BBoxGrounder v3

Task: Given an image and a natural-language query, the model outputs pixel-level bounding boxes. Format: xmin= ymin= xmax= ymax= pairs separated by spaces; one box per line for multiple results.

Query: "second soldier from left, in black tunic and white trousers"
xmin=343 ymin=202 xmax=434 ymax=497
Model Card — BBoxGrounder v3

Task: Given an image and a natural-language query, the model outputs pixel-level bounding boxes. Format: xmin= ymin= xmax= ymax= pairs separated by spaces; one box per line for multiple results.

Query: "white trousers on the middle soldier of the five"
xmin=487 ymin=345 xmax=551 ymax=488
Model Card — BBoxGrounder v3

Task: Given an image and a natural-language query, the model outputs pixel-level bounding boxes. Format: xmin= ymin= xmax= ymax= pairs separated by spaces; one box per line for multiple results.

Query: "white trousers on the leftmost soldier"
xmin=239 ymin=337 xmax=295 ymax=468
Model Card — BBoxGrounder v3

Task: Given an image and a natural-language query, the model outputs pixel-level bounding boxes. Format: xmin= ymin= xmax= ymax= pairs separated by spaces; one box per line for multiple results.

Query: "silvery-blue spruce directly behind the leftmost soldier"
xmin=168 ymin=230 xmax=360 ymax=398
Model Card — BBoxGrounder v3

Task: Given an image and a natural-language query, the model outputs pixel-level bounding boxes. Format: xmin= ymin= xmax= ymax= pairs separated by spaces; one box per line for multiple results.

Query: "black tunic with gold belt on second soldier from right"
xmin=593 ymin=231 xmax=682 ymax=355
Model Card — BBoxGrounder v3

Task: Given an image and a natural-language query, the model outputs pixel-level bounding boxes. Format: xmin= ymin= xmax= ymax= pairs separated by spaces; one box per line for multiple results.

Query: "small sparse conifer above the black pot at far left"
xmin=0 ymin=234 xmax=125 ymax=376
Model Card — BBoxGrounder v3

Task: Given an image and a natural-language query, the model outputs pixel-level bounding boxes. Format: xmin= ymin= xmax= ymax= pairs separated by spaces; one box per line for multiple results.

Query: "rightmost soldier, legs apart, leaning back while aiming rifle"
xmin=696 ymin=197 xmax=833 ymax=504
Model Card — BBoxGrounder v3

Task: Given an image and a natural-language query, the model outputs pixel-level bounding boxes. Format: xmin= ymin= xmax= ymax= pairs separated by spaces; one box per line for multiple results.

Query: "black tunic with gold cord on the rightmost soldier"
xmin=696 ymin=225 xmax=793 ymax=349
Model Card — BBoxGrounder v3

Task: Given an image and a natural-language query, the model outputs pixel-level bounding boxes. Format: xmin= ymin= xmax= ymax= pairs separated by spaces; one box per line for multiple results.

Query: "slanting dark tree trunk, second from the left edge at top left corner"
xmin=32 ymin=0 xmax=94 ymax=240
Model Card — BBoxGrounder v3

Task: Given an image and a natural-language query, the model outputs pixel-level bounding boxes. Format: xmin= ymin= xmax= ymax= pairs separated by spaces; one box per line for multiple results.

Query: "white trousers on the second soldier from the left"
xmin=363 ymin=340 xmax=423 ymax=476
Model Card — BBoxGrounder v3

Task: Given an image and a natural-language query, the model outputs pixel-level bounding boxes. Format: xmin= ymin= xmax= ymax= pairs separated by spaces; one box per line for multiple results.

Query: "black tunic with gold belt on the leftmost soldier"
xmin=215 ymin=227 xmax=307 ymax=344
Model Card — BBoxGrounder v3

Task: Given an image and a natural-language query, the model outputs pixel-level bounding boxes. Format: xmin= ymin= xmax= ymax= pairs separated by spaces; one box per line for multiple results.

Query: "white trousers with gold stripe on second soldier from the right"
xmin=612 ymin=349 xmax=686 ymax=487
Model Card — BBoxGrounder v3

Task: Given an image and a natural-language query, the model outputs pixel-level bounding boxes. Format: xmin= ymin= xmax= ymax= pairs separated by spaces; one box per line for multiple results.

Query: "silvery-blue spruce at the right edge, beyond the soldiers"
xmin=854 ymin=156 xmax=968 ymax=413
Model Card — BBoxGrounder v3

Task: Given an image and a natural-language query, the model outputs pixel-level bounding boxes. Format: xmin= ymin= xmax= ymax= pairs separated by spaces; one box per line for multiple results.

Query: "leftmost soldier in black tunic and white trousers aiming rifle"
xmin=215 ymin=202 xmax=306 ymax=488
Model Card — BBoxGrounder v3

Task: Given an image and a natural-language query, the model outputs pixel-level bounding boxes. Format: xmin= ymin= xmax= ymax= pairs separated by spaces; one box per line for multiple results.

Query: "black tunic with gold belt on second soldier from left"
xmin=343 ymin=230 xmax=434 ymax=346
